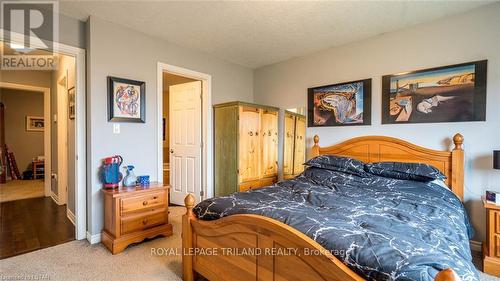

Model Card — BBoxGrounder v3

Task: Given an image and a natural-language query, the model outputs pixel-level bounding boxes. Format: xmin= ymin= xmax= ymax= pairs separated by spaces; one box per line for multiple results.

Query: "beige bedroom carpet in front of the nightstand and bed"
xmin=0 ymin=207 xmax=500 ymax=281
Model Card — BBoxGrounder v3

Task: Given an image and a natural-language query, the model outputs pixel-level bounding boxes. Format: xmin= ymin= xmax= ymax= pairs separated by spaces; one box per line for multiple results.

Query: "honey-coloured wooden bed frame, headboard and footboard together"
xmin=182 ymin=134 xmax=464 ymax=281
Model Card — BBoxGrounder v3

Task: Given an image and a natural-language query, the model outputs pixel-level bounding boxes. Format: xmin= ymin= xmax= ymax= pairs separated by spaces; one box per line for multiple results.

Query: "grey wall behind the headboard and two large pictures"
xmin=254 ymin=3 xmax=500 ymax=240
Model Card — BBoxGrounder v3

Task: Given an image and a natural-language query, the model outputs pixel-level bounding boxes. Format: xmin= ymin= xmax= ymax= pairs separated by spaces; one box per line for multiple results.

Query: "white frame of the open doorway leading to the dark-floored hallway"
xmin=0 ymin=29 xmax=87 ymax=240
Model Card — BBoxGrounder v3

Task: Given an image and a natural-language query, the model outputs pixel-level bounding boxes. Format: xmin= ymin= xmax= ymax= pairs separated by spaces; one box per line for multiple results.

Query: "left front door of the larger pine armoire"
xmin=238 ymin=106 xmax=260 ymax=182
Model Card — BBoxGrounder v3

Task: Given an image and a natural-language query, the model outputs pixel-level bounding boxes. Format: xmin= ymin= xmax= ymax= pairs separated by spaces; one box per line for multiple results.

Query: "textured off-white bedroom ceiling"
xmin=59 ymin=1 xmax=491 ymax=68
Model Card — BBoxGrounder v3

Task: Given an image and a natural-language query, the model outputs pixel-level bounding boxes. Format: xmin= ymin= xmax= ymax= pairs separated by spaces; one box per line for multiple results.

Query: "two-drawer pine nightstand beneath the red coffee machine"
xmin=102 ymin=183 xmax=172 ymax=254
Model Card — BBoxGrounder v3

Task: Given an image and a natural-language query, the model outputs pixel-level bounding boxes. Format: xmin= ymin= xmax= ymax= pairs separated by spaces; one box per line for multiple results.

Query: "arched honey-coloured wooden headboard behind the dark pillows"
xmin=312 ymin=134 xmax=464 ymax=200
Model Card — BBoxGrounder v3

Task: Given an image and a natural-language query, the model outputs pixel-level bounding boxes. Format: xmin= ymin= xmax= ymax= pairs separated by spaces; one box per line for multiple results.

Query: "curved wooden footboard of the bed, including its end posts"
xmin=182 ymin=194 xmax=460 ymax=281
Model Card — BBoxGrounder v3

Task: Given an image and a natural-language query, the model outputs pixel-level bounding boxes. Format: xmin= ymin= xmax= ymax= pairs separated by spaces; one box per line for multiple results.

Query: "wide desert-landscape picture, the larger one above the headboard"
xmin=381 ymin=60 xmax=487 ymax=124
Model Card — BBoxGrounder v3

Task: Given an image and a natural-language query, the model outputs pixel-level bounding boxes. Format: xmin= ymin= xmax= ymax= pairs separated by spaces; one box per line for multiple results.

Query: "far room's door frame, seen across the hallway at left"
xmin=0 ymin=81 xmax=52 ymax=197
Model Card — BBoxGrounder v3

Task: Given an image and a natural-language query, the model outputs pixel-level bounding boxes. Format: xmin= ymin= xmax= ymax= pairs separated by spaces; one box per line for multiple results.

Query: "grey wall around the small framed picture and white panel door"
xmin=86 ymin=17 xmax=253 ymax=234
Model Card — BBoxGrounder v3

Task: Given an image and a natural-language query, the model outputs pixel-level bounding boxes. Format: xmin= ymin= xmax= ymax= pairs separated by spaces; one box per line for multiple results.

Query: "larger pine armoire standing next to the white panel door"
xmin=214 ymin=102 xmax=279 ymax=196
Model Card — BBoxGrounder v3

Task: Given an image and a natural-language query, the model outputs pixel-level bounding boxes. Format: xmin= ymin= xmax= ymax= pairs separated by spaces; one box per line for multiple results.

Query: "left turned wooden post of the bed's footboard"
xmin=182 ymin=193 xmax=195 ymax=281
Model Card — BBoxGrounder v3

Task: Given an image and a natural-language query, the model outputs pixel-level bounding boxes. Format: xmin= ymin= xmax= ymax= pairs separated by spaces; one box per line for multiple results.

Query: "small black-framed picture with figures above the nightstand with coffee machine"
xmin=108 ymin=76 xmax=146 ymax=123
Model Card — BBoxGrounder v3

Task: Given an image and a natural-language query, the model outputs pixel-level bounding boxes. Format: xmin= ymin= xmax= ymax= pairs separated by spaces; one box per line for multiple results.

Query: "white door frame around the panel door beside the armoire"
xmin=156 ymin=62 xmax=214 ymax=200
